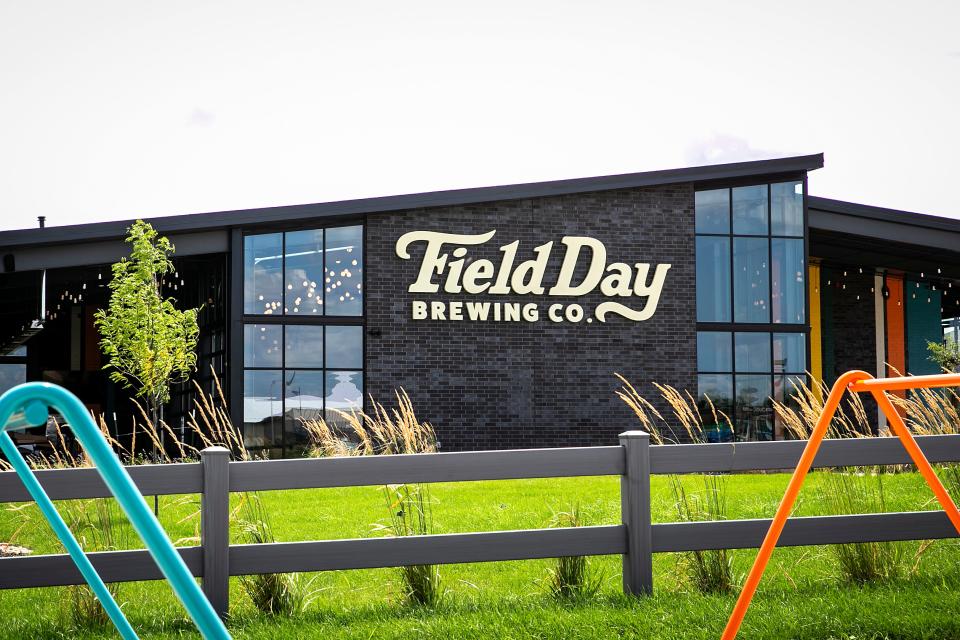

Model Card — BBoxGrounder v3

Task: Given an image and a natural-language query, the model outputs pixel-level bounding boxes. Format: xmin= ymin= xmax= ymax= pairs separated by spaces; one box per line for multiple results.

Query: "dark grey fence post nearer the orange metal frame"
xmin=620 ymin=431 xmax=653 ymax=595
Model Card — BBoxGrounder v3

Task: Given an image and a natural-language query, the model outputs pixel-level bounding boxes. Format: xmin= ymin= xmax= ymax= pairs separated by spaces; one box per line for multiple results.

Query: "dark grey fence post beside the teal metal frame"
xmin=200 ymin=447 xmax=230 ymax=618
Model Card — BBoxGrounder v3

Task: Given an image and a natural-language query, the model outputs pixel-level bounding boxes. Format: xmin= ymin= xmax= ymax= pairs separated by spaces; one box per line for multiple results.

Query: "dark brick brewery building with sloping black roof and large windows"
xmin=0 ymin=156 xmax=960 ymax=455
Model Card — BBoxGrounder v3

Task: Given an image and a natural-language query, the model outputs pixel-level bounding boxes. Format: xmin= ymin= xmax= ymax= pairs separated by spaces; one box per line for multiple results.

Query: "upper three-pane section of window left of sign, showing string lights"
xmin=243 ymin=225 xmax=363 ymax=316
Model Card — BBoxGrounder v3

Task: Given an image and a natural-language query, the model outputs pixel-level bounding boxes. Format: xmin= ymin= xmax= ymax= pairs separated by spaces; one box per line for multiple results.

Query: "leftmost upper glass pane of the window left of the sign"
xmin=243 ymin=233 xmax=283 ymax=315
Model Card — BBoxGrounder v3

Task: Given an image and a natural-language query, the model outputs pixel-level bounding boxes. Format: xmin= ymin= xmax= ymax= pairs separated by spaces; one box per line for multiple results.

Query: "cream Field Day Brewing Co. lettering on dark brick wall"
xmin=396 ymin=230 xmax=670 ymax=322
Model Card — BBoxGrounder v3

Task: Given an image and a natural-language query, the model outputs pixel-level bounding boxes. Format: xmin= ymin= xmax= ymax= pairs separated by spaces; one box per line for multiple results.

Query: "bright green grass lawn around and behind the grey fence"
xmin=0 ymin=473 xmax=960 ymax=640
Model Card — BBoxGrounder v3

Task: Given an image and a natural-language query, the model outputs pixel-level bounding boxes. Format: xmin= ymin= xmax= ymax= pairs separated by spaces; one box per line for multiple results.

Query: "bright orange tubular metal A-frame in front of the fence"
xmin=721 ymin=371 xmax=960 ymax=640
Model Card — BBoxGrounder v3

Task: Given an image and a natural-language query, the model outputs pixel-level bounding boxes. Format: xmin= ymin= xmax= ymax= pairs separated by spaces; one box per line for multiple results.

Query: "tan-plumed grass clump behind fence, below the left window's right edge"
xmin=303 ymin=389 xmax=444 ymax=606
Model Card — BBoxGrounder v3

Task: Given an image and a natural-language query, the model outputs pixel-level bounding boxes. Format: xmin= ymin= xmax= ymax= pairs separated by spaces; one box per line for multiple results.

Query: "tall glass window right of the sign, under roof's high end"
xmin=695 ymin=181 xmax=807 ymax=442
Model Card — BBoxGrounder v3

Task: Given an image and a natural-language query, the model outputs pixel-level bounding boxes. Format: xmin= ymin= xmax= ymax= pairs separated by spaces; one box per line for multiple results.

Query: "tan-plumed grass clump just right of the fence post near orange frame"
xmin=616 ymin=374 xmax=737 ymax=593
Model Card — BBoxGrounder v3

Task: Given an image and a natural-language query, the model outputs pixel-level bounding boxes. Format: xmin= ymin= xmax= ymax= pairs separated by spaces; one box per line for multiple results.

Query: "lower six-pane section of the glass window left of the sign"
xmin=243 ymin=324 xmax=363 ymax=457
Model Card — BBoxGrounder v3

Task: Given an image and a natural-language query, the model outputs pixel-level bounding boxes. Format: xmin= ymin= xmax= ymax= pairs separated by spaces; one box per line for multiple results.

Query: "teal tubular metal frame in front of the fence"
xmin=0 ymin=382 xmax=230 ymax=640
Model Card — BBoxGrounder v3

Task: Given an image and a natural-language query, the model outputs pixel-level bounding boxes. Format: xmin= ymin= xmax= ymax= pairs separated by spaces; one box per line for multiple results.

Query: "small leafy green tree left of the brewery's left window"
xmin=95 ymin=220 xmax=199 ymax=440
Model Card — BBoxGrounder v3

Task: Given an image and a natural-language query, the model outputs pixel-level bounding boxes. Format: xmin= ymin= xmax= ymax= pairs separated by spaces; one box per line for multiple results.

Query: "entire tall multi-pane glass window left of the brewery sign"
xmin=243 ymin=225 xmax=363 ymax=457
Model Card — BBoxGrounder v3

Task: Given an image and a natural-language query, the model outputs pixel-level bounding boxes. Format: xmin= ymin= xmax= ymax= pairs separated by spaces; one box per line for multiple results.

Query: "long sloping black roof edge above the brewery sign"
xmin=0 ymin=153 xmax=823 ymax=248
